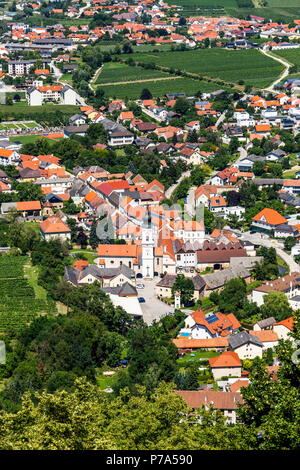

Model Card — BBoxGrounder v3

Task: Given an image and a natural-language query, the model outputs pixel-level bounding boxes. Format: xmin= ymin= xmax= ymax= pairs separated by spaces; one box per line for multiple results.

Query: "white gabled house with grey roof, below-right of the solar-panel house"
xmin=228 ymin=331 xmax=263 ymax=360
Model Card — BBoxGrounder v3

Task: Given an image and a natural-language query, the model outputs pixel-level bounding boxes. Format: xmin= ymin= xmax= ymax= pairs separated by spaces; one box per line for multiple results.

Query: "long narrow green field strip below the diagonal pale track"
xmin=98 ymin=76 xmax=232 ymax=99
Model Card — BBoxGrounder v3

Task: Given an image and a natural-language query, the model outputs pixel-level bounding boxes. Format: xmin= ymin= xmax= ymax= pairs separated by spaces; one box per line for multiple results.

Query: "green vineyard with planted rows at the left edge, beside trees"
xmin=0 ymin=256 xmax=55 ymax=334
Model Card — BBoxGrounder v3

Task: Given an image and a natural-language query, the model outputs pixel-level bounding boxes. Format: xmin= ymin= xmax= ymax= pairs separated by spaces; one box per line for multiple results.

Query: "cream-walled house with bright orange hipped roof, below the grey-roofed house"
xmin=208 ymin=351 xmax=242 ymax=380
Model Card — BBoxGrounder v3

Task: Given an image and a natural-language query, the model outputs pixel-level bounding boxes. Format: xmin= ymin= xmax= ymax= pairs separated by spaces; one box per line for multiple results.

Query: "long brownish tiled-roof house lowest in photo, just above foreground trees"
xmin=174 ymin=390 xmax=243 ymax=424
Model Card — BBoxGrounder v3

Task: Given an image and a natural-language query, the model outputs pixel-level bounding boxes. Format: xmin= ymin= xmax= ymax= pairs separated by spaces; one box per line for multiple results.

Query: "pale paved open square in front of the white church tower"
xmin=137 ymin=277 xmax=174 ymax=325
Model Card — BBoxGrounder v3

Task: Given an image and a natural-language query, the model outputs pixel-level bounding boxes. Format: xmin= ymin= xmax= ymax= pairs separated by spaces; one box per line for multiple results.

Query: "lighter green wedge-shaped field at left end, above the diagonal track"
xmin=96 ymin=62 xmax=169 ymax=85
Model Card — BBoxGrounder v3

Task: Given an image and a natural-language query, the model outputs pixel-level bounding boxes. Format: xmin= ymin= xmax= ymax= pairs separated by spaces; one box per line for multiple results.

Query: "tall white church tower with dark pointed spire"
xmin=142 ymin=209 xmax=155 ymax=279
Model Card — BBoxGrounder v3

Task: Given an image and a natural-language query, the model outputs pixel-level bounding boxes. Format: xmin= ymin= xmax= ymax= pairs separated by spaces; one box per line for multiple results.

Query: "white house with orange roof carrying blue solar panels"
xmin=182 ymin=310 xmax=241 ymax=339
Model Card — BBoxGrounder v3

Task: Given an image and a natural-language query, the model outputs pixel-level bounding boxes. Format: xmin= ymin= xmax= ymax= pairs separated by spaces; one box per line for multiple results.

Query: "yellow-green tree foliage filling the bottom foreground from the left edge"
xmin=0 ymin=378 xmax=237 ymax=450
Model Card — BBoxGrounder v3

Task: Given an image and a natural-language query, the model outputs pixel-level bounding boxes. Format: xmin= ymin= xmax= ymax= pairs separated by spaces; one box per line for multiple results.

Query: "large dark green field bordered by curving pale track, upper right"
xmin=122 ymin=49 xmax=284 ymax=88
